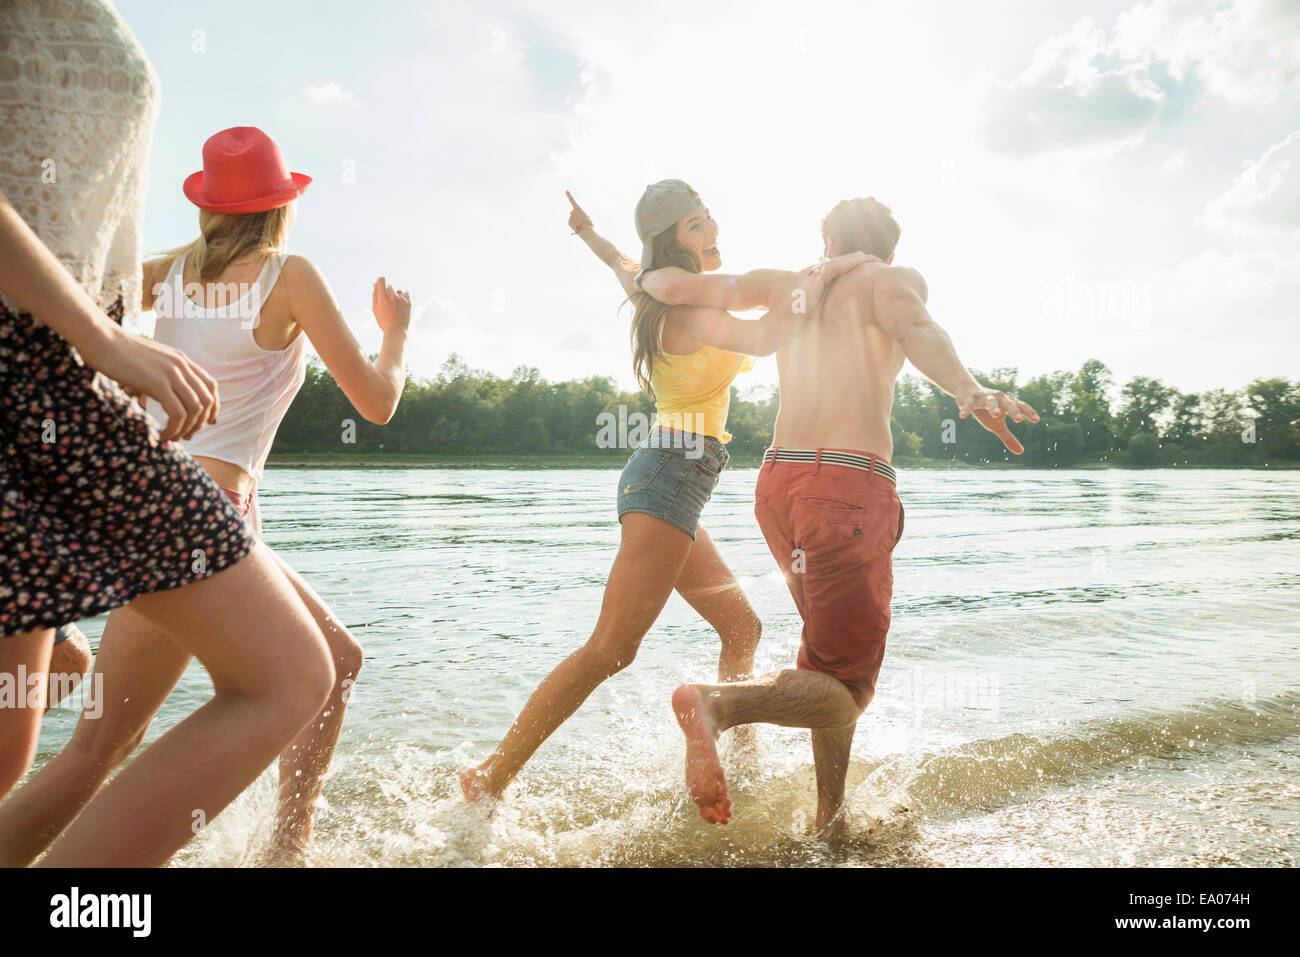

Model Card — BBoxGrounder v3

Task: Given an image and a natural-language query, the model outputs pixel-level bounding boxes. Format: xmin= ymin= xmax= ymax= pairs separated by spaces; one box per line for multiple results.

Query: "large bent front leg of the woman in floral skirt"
xmin=42 ymin=544 xmax=334 ymax=867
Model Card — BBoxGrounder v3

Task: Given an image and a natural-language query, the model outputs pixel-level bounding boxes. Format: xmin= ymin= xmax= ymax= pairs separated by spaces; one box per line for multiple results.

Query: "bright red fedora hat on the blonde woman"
xmin=182 ymin=126 xmax=312 ymax=213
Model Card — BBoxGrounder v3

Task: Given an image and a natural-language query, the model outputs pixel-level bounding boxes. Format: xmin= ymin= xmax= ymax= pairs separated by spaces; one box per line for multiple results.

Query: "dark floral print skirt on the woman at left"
xmin=0 ymin=303 xmax=254 ymax=637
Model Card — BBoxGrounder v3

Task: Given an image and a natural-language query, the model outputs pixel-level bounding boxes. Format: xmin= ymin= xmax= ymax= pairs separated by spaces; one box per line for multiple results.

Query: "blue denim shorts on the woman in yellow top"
xmin=619 ymin=429 xmax=731 ymax=541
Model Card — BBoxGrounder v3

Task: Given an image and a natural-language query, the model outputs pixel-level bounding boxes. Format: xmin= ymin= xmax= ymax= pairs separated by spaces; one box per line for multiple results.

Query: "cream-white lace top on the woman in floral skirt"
xmin=0 ymin=0 xmax=159 ymax=323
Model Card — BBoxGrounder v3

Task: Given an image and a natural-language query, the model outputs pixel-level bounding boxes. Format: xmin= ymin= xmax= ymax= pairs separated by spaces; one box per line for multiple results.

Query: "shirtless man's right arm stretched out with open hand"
xmin=872 ymin=267 xmax=1039 ymax=455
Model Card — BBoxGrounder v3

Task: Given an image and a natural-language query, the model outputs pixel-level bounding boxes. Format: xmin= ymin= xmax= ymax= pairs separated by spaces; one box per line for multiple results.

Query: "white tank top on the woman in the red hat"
xmin=147 ymin=254 xmax=307 ymax=482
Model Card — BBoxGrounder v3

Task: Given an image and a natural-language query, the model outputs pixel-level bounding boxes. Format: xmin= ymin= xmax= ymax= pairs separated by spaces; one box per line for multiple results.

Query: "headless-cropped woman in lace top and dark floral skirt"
xmin=0 ymin=0 xmax=334 ymax=866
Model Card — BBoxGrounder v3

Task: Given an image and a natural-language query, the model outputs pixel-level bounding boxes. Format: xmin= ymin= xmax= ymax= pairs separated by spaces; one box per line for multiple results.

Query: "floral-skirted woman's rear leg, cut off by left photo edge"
xmin=0 ymin=628 xmax=55 ymax=800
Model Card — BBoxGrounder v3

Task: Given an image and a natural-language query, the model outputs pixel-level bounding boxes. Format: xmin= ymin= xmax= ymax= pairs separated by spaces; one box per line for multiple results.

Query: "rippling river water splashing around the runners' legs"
xmin=38 ymin=468 xmax=1300 ymax=866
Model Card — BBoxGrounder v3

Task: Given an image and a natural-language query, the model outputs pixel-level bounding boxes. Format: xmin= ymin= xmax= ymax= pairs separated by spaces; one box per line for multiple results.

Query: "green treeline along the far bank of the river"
xmin=273 ymin=355 xmax=1300 ymax=468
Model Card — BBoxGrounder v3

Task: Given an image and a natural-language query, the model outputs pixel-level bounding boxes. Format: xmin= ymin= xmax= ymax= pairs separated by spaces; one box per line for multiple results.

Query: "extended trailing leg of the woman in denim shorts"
xmin=460 ymin=512 xmax=692 ymax=801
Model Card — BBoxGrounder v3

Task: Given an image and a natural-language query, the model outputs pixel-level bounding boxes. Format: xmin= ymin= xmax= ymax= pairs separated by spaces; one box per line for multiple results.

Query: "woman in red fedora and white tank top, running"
xmin=0 ymin=126 xmax=411 ymax=866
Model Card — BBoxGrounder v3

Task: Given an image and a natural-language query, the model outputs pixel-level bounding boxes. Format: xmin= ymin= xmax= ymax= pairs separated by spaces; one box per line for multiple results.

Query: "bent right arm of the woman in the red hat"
xmin=283 ymin=256 xmax=411 ymax=425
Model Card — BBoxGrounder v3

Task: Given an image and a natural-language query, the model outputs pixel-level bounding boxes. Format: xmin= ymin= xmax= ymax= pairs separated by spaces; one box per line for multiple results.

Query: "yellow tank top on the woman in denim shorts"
xmin=650 ymin=346 xmax=754 ymax=442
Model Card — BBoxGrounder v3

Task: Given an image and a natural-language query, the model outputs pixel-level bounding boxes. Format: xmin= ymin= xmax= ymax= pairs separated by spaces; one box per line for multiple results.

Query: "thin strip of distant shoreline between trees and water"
xmin=267 ymin=451 xmax=1300 ymax=472
